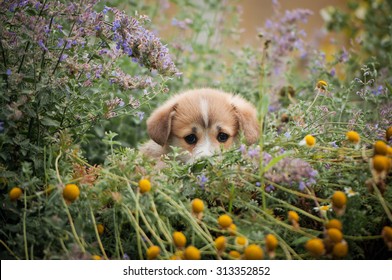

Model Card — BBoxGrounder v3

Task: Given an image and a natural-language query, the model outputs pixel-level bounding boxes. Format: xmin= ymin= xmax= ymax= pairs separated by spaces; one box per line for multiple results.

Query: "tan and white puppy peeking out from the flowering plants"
xmin=140 ymin=88 xmax=260 ymax=162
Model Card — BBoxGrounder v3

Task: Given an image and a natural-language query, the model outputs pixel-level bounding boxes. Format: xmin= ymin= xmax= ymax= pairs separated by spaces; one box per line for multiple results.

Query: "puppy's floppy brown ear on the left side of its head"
xmin=147 ymin=102 xmax=176 ymax=146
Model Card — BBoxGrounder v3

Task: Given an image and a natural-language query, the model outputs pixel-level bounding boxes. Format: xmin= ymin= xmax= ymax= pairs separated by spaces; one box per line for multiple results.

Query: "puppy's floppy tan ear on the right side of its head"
xmin=232 ymin=96 xmax=260 ymax=145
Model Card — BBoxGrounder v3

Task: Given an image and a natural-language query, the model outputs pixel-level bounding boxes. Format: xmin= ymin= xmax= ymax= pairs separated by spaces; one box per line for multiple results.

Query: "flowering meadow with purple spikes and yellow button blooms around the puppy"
xmin=0 ymin=0 xmax=392 ymax=260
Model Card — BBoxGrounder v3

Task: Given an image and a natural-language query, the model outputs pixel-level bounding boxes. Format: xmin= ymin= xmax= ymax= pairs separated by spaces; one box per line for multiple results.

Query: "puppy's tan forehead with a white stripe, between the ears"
xmin=173 ymin=92 xmax=235 ymax=128
